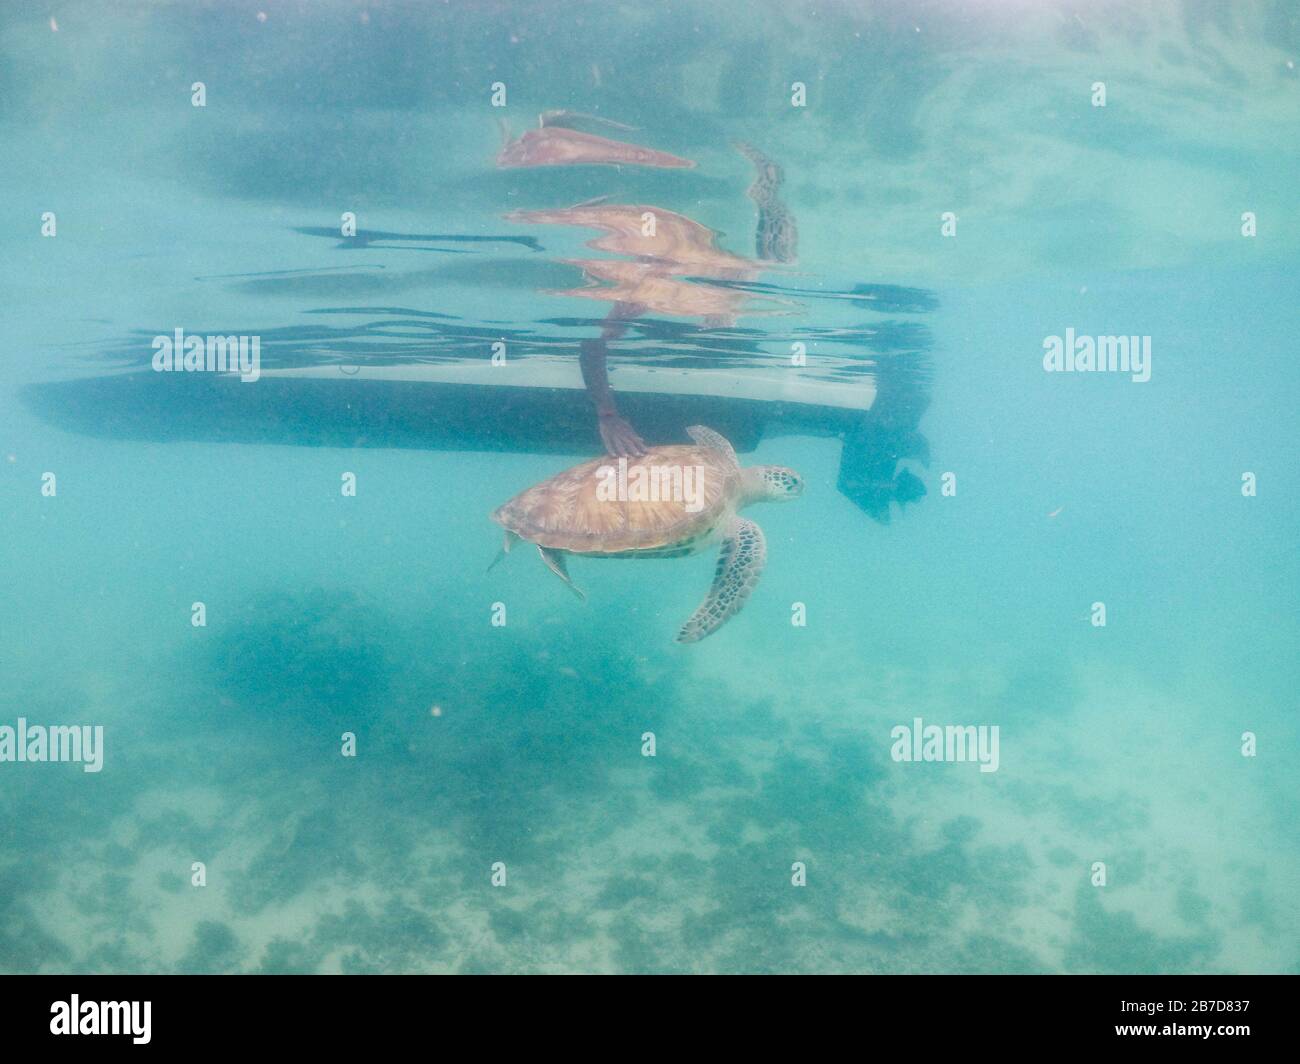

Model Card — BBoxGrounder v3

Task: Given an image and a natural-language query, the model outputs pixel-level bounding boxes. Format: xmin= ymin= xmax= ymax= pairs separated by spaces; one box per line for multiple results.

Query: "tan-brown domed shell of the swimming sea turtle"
xmin=491 ymin=444 xmax=741 ymax=554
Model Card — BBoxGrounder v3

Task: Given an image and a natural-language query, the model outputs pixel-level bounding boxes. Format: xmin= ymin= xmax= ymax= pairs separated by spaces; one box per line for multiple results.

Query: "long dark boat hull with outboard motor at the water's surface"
xmin=22 ymin=244 xmax=936 ymax=522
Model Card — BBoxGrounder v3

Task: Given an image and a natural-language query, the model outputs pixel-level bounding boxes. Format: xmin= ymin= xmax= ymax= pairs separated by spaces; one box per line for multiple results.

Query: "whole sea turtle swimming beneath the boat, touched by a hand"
xmin=489 ymin=425 xmax=803 ymax=643
